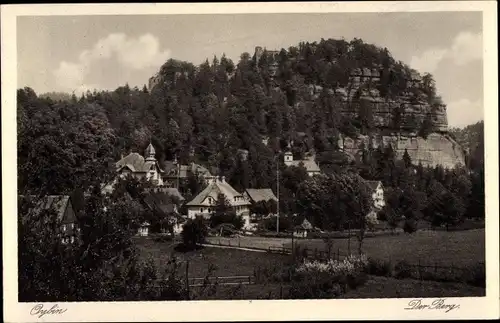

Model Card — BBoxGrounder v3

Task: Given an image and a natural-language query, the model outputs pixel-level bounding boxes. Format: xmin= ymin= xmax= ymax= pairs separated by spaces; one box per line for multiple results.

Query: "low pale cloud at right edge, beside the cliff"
xmin=446 ymin=99 xmax=484 ymax=127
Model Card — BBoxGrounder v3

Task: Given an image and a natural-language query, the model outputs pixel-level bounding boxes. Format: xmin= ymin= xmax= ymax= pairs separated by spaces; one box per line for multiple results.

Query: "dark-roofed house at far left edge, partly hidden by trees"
xmin=21 ymin=195 xmax=80 ymax=244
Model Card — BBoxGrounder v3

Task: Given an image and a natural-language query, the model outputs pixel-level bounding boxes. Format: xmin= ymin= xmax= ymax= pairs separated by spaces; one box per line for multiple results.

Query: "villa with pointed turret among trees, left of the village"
xmin=102 ymin=143 xmax=164 ymax=194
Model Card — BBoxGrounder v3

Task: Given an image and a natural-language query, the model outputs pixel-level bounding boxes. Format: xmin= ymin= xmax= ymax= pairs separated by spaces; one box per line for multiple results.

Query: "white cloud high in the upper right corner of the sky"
xmin=410 ymin=32 xmax=483 ymax=73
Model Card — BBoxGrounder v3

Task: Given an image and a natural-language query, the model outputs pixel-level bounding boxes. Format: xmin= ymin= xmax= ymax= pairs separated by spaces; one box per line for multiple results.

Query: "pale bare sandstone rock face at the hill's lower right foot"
xmin=339 ymin=133 xmax=465 ymax=168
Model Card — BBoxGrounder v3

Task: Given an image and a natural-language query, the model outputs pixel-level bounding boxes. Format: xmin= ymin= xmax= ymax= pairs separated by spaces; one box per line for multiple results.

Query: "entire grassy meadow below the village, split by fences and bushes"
xmin=136 ymin=230 xmax=485 ymax=300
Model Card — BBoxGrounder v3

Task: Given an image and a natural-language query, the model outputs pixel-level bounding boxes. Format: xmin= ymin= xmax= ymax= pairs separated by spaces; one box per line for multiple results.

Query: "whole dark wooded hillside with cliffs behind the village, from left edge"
xmin=18 ymin=39 xmax=464 ymax=192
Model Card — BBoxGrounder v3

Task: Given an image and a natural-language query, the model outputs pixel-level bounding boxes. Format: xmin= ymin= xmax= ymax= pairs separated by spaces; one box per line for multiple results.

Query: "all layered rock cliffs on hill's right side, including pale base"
xmin=330 ymin=69 xmax=465 ymax=168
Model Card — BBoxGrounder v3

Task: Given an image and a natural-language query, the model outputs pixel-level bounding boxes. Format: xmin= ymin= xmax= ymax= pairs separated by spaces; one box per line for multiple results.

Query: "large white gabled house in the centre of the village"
xmin=186 ymin=176 xmax=250 ymax=219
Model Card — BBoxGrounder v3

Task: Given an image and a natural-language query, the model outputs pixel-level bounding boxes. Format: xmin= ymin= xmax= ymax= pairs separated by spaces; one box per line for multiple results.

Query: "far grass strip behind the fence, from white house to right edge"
xmin=208 ymin=229 xmax=485 ymax=267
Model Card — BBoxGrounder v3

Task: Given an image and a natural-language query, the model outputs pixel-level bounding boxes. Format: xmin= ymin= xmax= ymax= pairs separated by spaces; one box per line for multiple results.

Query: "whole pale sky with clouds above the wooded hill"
xmin=17 ymin=12 xmax=483 ymax=127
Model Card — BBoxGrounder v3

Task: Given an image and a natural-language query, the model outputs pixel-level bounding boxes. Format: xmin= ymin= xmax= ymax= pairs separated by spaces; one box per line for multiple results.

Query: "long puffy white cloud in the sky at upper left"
xmin=54 ymin=33 xmax=170 ymax=92
